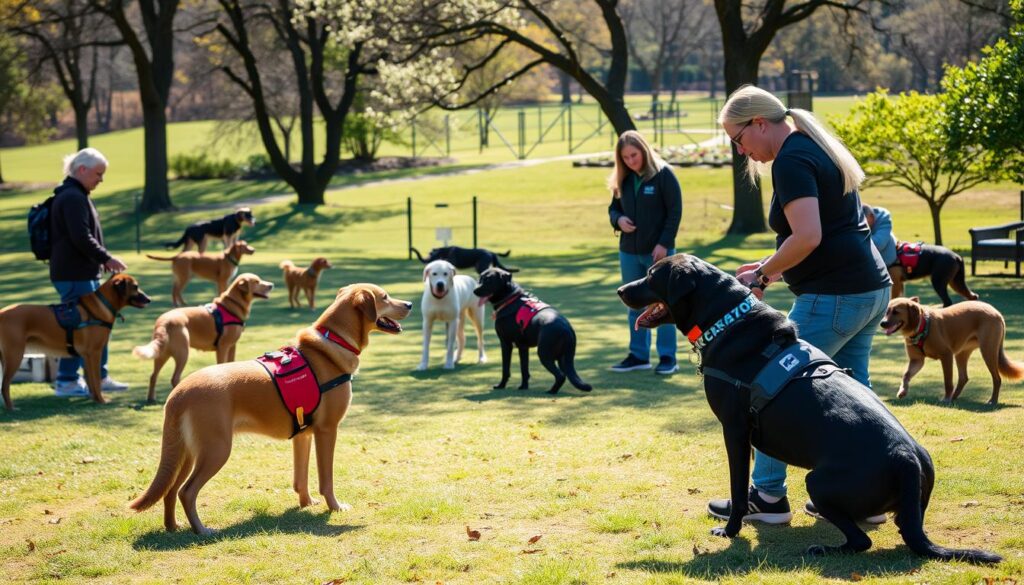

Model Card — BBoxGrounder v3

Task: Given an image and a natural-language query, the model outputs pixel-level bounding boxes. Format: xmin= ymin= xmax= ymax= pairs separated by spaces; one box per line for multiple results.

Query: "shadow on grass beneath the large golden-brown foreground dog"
xmin=132 ymin=508 xmax=365 ymax=550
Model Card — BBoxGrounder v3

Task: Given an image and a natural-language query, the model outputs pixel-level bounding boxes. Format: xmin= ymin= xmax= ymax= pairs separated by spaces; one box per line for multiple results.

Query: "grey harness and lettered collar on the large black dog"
xmin=687 ymin=294 xmax=849 ymax=421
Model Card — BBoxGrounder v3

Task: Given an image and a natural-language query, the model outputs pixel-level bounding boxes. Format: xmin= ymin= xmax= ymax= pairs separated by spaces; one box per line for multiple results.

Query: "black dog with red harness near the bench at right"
xmin=889 ymin=242 xmax=979 ymax=306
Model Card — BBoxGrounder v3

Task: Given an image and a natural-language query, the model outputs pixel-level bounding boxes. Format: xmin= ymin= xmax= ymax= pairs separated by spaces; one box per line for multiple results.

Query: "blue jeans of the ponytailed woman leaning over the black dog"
xmin=751 ymin=287 xmax=891 ymax=498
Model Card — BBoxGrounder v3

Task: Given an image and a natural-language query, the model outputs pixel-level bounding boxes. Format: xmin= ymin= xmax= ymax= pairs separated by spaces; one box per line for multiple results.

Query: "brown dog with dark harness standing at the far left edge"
xmin=0 ymin=274 xmax=150 ymax=410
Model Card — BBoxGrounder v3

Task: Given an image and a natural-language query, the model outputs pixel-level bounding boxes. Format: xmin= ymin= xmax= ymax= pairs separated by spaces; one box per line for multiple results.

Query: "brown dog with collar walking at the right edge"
xmin=881 ymin=297 xmax=1024 ymax=405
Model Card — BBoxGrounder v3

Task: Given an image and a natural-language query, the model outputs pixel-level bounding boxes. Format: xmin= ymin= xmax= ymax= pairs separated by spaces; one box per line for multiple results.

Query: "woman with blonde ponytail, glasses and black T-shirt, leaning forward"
xmin=708 ymin=86 xmax=892 ymax=524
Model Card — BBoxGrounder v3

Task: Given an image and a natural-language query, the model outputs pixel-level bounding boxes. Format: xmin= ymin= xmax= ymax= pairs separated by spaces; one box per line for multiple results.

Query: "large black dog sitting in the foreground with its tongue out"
xmin=618 ymin=254 xmax=1001 ymax=563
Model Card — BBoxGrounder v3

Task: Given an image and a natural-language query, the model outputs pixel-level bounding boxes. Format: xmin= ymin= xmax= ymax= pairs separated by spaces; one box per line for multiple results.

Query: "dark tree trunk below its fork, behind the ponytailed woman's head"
xmin=725 ymin=45 xmax=767 ymax=235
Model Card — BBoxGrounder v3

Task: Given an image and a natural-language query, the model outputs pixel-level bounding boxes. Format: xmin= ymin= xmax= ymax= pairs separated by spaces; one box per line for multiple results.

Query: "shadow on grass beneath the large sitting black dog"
xmin=616 ymin=521 xmax=928 ymax=580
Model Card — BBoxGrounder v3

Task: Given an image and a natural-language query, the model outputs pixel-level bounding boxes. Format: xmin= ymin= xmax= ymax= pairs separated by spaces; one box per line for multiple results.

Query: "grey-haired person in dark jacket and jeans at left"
xmin=50 ymin=149 xmax=128 ymax=396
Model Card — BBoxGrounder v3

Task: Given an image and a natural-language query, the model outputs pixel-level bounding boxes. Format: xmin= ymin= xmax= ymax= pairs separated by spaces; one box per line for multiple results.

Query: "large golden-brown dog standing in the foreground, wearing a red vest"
xmin=129 ymin=284 xmax=413 ymax=535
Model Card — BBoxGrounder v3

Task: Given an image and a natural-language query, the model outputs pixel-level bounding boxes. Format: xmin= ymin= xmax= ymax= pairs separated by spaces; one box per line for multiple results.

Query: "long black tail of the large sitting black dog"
xmin=896 ymin=453 xmax=1002 ymax=565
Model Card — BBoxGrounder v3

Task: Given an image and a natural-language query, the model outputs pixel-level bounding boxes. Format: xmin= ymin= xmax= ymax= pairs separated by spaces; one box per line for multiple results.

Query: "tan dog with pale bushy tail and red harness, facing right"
xmin=132 ymin=273 xmax=273 ymax=403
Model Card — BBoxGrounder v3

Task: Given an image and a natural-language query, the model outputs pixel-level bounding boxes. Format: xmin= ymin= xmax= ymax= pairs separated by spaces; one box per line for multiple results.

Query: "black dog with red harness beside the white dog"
xmin=473 ymin=268 xmax=593 ymax=394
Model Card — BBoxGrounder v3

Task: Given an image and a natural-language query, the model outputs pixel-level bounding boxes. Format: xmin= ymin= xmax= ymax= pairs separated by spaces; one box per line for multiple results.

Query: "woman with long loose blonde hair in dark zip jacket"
xmin=608 ymin=130 xmax=683 ymax=375
